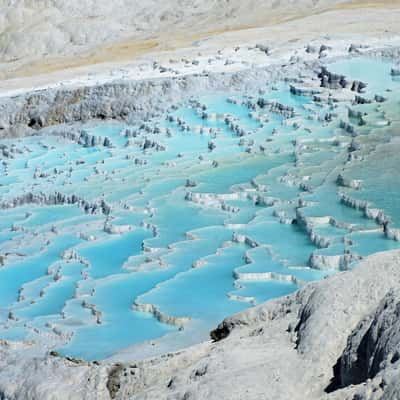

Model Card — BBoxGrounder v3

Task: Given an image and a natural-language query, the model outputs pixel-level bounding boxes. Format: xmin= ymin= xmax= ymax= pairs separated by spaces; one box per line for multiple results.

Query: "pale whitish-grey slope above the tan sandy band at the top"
xmin=0 ymin=0 xmax=345 ymax=62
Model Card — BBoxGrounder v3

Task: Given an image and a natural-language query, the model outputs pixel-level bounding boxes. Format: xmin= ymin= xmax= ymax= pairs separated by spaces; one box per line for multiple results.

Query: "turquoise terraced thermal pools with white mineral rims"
xmin=0 ymin=58 xmax=400 ymax=360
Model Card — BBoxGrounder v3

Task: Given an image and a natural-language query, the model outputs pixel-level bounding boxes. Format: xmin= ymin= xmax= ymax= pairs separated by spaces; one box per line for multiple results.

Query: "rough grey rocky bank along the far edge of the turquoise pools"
xmin=0 ymin=66 xmax=293 ymax=137
